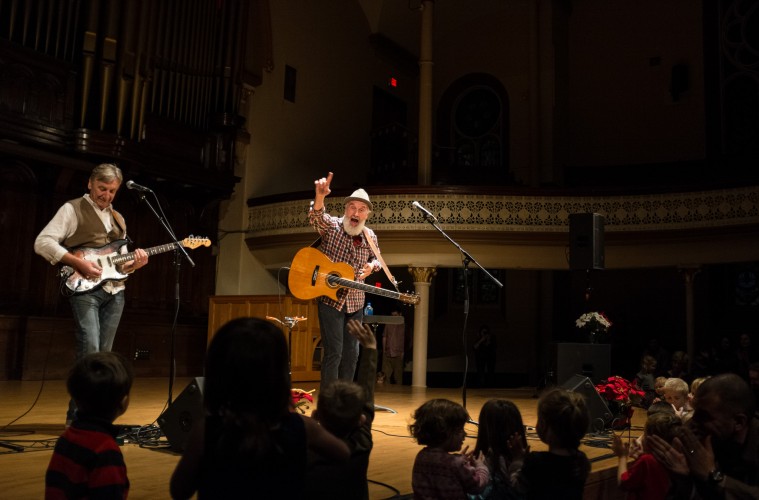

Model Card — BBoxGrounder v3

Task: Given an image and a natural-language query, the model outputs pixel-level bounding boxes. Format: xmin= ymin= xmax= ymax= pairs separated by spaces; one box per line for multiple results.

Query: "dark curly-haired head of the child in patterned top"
xmin=409 ymin=399 xmax=469 ymax=447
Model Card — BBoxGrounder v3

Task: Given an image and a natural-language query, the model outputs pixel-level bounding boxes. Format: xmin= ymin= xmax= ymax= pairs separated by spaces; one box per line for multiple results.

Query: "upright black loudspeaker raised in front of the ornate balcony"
xmin=569 ymin=213 xmax=604 ymax=270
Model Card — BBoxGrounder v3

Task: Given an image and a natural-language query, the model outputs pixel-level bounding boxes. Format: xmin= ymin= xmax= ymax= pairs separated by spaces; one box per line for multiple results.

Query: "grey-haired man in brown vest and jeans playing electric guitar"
xmin=34 ymin=163 xmax=148 ymax=425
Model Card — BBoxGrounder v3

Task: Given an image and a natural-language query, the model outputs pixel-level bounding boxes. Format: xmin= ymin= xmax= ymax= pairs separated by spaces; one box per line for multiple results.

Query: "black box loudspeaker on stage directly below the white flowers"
xmin=551 ymin=342 xmax=611 ymax=383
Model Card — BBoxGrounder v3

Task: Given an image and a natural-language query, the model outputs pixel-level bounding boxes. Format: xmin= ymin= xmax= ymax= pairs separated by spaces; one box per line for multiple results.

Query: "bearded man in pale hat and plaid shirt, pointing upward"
xmin=308 ymin=172 xmax=382 ymax=386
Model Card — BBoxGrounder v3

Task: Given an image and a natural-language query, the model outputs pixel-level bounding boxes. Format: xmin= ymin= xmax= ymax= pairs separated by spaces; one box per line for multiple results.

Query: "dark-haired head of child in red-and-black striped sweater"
xmin=66 ymin=352 xmax=134 ymax=421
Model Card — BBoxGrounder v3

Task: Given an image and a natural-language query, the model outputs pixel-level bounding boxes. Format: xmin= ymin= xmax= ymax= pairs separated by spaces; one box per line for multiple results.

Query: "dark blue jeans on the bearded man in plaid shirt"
xmin=319 ymin=302 xmax=364 ymax=387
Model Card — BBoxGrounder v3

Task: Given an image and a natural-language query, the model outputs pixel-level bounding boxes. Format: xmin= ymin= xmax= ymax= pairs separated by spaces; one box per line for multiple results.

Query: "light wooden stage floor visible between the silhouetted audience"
xmin=0 ymin=378 xmax=645 ymax=499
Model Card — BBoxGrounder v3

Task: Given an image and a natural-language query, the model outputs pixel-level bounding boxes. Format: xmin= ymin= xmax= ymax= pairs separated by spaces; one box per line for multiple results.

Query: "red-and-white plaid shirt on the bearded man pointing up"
xmin=308 ymin=208 xmax=382 ymax=314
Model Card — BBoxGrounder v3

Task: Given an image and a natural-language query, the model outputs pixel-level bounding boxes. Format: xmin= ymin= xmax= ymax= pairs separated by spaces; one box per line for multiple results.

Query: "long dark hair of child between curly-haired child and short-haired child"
xmin=474 ymin=399 xmax=526 ymax=460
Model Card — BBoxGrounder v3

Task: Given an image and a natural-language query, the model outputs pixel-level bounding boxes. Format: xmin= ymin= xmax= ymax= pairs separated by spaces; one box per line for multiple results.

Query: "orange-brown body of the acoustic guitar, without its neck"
xmin=287 ymin=247 xmax=354 ymax=300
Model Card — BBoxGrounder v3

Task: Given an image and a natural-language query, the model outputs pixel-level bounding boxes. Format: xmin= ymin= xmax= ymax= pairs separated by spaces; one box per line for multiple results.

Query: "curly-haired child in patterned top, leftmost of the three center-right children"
xmin=409 ymin=399 xmax=490 ymax=500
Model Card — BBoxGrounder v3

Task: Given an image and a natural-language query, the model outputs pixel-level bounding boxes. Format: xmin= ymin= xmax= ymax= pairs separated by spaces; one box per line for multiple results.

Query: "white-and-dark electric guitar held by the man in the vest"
xmin=58 ymin=235 xmax=211 ymax=295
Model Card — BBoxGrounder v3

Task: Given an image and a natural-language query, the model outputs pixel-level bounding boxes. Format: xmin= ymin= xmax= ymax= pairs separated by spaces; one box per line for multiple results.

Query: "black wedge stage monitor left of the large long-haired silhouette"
xmin=158 ymin=377 xmax=204 ymax=451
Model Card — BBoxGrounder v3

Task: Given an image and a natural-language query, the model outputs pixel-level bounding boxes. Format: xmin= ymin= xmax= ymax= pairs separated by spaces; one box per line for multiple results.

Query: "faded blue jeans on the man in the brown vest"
xmin=66 ymin=288 xmax=124 ymax=420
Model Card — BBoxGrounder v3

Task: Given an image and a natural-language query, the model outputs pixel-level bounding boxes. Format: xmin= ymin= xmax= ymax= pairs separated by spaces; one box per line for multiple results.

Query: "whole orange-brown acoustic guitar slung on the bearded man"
xmin=287 ymin=247 xmax=419 ymax=304
